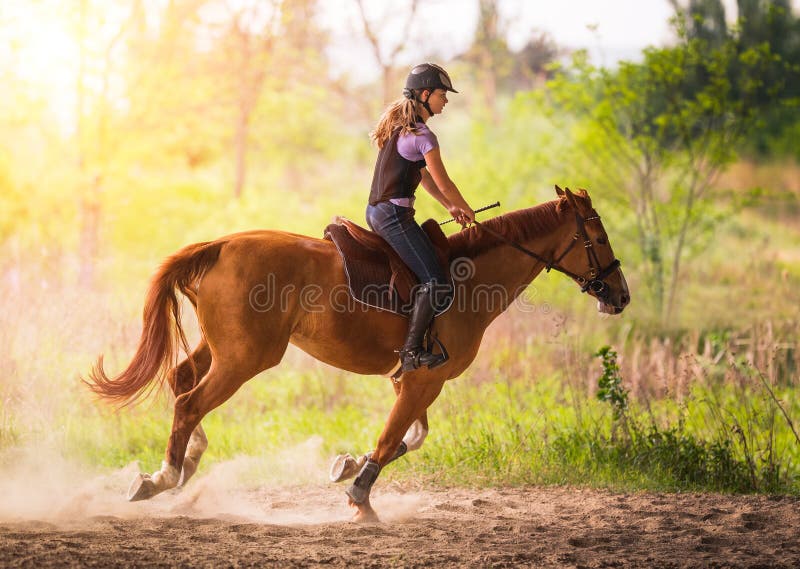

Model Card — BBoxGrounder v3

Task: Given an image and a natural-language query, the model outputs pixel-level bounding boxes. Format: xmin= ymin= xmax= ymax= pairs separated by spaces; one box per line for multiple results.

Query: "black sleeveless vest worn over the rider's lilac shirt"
xmin=369 ymin=129 xmax=425 ymax=205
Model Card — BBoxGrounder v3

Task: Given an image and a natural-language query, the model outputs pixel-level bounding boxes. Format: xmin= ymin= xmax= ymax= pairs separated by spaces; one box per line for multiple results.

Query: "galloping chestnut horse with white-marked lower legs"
xmin=86 ymin=186 xmax=630 ymax=520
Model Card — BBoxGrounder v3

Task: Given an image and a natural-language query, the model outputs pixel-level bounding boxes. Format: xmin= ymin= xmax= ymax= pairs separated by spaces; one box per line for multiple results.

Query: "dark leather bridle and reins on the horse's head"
xmin=473 ymin=211 xmax=620 ymax=302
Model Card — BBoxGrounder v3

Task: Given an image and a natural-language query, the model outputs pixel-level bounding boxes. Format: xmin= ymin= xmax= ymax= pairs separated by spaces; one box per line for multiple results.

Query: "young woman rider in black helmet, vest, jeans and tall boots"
xmin=367 ymin=63 xmax=475 ymax=371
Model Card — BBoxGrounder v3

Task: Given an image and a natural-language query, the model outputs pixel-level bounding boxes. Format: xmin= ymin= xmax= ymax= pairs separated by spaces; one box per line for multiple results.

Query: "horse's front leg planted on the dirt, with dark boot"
xmin=346 ymin=380 xmax=444 ymax=521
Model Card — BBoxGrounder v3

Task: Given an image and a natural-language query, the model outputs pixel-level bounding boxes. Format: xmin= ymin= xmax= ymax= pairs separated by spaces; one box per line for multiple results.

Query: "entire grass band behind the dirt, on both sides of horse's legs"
xmin=0 ymin=338 xmax=800 ymax=494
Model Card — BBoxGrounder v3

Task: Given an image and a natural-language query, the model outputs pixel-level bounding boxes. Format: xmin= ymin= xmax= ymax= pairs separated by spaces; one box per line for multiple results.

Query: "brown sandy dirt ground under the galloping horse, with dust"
xmin=0 ymin=481 xmax=800 ymax=567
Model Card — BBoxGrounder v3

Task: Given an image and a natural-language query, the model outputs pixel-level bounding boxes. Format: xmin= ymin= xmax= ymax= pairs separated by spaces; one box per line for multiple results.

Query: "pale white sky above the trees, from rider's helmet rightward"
xmin=320 ymin=0 xmax=724 ymax=79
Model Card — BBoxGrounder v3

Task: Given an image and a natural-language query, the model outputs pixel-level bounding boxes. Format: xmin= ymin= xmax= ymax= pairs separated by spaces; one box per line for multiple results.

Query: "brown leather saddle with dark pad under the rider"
xmin=324 ymin=217 xmax=450 ymax=316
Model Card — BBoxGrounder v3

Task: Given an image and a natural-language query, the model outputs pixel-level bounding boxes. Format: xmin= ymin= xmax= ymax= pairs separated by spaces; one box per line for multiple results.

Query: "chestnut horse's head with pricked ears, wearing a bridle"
xmin=556 ymin=186 xmax=631 ymax=314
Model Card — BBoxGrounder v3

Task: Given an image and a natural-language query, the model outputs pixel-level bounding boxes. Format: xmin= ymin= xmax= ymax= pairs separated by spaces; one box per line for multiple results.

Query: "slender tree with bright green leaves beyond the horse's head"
xmin=548 ymin=31 xmax=771 ymax=324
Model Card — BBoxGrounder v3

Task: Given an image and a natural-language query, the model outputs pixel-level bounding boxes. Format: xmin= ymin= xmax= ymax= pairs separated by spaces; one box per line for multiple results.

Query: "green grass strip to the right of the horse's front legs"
xmin=401 ymin=364 xmax=800 ymax=494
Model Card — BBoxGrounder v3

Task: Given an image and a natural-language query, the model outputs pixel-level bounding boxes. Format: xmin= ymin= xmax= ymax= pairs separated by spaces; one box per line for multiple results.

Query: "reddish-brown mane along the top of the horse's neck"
xmin=447 ymin=198 xmax=566 ymax=259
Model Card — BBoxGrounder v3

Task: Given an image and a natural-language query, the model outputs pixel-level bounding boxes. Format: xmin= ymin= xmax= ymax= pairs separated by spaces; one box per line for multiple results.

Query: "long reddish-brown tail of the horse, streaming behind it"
xmin=83 ymin=241 xmax=226 ymax=406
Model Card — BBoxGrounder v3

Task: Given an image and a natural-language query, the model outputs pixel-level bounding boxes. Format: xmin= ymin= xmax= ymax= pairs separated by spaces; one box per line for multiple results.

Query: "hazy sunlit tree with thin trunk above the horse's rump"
xmin=184 ymin=0 xmax=332 ymax=198
